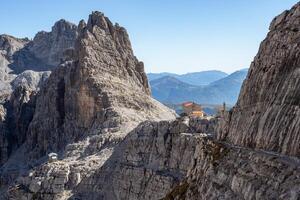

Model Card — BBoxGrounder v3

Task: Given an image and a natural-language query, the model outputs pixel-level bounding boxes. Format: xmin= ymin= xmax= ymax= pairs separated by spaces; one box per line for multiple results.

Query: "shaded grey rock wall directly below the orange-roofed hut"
xmin=73 ymin=119 xmax=214 ymax=200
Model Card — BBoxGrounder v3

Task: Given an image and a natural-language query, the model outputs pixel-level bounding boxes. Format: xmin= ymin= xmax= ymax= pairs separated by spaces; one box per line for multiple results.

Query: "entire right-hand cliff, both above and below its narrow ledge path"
xmin=164 ymin=3 xmax=300 ymax=200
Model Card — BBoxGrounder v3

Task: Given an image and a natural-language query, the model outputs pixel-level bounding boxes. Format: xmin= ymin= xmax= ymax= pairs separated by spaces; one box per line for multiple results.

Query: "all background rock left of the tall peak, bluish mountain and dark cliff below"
xmin=0 ymin=20 xmax=77 ymax=165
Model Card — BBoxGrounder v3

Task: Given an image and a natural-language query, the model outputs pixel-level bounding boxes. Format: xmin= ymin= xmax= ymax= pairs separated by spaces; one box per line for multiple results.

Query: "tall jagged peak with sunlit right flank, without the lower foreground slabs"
xmin=24 ymin=12 xmax=166 ymax=158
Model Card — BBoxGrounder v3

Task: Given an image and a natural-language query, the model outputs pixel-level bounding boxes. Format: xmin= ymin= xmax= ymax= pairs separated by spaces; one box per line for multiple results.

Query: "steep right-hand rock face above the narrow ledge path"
xmin=219 ymin=4 xmax=300 ymax=156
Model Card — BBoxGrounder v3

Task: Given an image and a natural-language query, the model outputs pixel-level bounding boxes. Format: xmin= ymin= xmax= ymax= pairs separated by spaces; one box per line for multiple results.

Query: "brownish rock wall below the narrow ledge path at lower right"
xmin=164 ymin=139 xmax=300 ymax=200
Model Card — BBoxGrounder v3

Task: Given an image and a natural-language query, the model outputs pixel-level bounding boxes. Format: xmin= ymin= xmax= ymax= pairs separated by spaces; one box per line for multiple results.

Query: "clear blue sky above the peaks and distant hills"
xmin=0 ymin=0 xmax=297 ymax=73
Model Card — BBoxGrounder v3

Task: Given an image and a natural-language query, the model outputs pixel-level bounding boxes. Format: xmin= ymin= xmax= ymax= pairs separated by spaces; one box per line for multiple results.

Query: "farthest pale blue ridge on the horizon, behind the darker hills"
xmin=147 ymin=70 xmax=228 ymax=86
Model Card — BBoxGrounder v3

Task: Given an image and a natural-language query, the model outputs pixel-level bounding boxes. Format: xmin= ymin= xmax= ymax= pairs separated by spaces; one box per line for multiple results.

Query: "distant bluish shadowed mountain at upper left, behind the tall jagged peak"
xmin=0 ymin=20 xmax=77 ymax=100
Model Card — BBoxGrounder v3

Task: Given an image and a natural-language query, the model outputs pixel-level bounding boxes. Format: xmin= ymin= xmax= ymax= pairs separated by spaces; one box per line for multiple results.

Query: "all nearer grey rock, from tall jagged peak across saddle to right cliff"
xmin=0 ymin=4 xmax=300 ymax=200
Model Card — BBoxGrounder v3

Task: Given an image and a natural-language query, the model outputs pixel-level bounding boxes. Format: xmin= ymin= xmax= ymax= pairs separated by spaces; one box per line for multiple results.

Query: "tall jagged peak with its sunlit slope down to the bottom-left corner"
xmin=1 ymin=12 xmax=175 ymax=199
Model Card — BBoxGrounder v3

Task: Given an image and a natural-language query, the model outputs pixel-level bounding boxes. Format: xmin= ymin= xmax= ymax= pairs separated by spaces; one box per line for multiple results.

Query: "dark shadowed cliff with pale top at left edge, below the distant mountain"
xmin=0 ymin=71 xmax=50 ymax=165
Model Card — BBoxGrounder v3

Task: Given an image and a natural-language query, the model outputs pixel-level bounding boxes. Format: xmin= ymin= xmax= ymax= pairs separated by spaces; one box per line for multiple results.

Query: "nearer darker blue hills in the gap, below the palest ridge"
xmin=148 ymin=69 xmax=248 ymax=105
